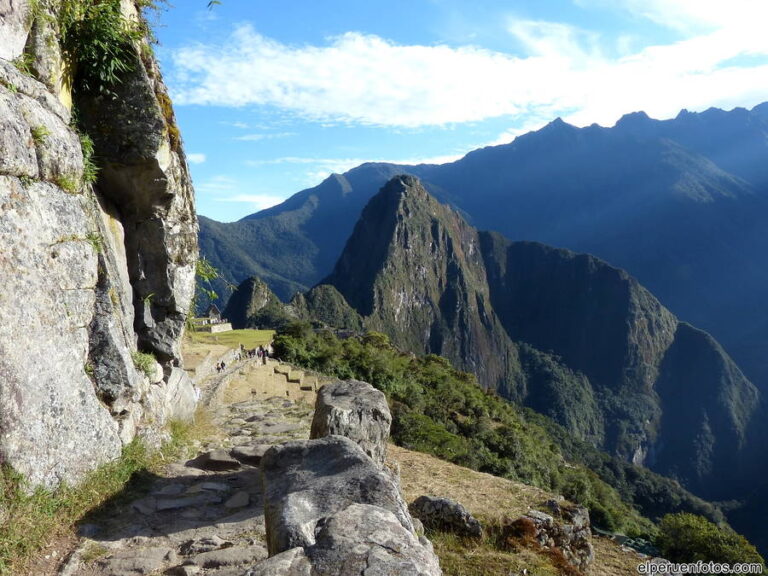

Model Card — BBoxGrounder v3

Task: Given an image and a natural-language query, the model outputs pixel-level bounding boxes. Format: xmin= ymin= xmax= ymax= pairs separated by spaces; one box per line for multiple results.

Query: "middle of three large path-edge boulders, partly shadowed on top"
xmin=261 ymin=436 xmax=414 ymax=556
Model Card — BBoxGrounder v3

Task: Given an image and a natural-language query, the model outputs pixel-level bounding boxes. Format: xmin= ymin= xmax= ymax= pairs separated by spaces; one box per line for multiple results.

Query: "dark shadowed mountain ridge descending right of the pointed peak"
xmin=481 ymin=233 xmax=760 ymax=498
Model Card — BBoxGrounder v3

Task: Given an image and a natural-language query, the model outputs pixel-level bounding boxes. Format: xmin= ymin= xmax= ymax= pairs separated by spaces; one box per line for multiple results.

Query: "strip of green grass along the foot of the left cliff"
xmin=0 ymin=412 xmax=211 ymax=576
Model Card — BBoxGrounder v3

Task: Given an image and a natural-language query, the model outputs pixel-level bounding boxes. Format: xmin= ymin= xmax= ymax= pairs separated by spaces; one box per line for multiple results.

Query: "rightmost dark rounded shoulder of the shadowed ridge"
xmin=653 ymin=322 xmax=764 ymax=499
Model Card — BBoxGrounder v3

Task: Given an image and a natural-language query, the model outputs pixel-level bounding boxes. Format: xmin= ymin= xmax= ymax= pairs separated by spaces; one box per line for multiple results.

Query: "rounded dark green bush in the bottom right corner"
xmin=656 ymin=513 xmax=765 ymax=566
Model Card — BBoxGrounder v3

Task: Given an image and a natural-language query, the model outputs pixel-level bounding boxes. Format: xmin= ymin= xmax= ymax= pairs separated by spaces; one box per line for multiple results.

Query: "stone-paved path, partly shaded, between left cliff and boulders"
xmin=60 ymin=359 xmax=317 ymax=576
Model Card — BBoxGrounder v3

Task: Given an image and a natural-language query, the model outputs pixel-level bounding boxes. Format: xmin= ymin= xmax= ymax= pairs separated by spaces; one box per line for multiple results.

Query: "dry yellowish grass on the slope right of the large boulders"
xmin=388 ymin=444 xmax=640 ymax=576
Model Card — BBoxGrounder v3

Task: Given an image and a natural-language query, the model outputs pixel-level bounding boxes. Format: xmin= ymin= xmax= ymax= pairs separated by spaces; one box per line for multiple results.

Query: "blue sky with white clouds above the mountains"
xmin=151 ymin=0 xmax=768 ymax=222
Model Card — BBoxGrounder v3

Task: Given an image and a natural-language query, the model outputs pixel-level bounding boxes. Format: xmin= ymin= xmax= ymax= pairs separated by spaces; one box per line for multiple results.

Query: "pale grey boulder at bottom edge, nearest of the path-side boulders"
xmin=250 ymin=504 xmax=442 ymax=576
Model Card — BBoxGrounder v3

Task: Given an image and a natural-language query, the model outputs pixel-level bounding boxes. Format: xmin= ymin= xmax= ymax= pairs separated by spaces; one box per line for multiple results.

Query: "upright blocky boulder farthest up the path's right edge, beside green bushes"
xmin=310 ymin=380 xmax=392 ymax=468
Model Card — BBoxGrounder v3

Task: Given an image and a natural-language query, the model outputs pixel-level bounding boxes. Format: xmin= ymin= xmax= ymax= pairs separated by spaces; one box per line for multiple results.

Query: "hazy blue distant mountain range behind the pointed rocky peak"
xmin=200 ymin=103 xmax=768 ymax=396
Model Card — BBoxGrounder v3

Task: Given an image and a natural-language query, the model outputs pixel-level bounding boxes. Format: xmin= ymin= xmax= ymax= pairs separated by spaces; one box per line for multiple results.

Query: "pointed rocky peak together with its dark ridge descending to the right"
xmin=308 ymin=176 xmax=760 ymax=498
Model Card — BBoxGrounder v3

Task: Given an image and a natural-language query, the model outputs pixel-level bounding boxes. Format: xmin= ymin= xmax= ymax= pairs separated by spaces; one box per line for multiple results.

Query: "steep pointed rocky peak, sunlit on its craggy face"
xmin=323 ymin=176 xmax=522 ymax=397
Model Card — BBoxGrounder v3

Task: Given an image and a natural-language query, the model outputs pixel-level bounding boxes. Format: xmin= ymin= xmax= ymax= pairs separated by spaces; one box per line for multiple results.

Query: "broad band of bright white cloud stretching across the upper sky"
xmin=173 ymin=8 xmax=768 ymax=130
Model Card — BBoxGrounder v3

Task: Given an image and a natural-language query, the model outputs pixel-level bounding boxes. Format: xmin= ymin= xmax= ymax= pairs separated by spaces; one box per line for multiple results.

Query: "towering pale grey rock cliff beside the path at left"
xmin=0 ymin=0 xmax=197 ymax=486
